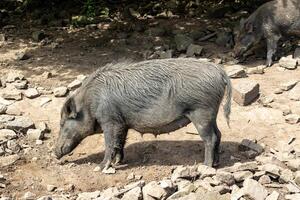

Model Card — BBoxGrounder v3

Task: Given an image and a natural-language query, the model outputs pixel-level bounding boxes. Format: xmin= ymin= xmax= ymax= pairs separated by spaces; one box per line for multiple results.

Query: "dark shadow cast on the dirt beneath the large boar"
xmin=73 ymin=140 xmax=249 ymax=169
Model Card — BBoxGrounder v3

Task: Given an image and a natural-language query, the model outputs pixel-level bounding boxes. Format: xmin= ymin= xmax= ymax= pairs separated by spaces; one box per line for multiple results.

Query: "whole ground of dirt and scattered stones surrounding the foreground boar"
xmin=0 ymin=12 xmax=300 ymax=200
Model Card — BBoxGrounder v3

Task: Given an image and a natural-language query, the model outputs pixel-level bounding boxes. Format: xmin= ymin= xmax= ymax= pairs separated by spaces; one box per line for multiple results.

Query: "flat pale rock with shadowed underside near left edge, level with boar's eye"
xmin=4 ymin=116 xmax=34 ymax=133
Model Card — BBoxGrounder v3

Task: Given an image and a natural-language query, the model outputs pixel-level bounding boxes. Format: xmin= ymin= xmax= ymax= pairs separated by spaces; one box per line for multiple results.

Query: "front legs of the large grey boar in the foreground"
xmin=100 ymin=123 xmax=127 ymax=169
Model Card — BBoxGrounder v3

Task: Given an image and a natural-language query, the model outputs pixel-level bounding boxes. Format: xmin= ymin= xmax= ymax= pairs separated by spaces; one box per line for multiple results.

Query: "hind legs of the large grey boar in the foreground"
xmin=188 ymin=110 xmax=220 ymax=167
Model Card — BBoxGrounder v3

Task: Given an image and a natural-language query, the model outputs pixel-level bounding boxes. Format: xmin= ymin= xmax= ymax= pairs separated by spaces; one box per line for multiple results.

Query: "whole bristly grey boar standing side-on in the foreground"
xmin=55 ymin=58 xmax=232 ymax=168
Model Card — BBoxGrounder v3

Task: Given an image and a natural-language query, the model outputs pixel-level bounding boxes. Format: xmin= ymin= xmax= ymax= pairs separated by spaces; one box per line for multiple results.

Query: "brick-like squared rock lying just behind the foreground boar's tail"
xmin=233 ymin=80 xmax=259 ymax=106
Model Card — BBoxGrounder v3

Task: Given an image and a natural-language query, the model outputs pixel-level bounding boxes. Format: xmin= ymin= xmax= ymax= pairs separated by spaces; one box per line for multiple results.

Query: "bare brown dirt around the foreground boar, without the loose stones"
xmin=0 ymin=19 xmax=300 ymax=199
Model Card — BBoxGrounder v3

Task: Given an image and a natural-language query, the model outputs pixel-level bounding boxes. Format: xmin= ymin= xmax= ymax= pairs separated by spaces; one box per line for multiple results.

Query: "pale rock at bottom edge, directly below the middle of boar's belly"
xmin=143 ymin=181 xmax=167 ymax=200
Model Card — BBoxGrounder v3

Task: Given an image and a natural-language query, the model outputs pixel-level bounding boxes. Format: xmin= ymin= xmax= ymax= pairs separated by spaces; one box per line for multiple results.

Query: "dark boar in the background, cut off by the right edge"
xmin=234 ymin=0 xmax=300 ymax=66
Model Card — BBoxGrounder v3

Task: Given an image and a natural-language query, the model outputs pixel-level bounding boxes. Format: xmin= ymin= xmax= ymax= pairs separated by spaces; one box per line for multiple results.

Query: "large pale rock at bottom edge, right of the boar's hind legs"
xmin=243 ymin=179 xmax=268 ymax=200
